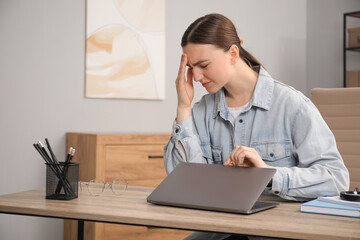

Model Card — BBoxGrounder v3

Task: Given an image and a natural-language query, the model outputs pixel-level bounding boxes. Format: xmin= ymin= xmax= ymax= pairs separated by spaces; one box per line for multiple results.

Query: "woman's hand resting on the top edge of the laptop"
xmin=224 ymin=146 xmax=269 ymax=168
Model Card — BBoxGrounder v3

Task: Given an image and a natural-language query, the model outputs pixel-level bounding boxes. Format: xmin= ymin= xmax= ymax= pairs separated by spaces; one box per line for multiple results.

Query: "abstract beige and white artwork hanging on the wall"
xmin=85 ymin=0 xmax=165 ymax=100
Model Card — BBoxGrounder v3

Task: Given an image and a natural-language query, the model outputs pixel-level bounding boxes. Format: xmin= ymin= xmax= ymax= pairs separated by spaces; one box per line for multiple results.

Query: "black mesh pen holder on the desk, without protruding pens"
xmin=46 ymin=162 xmax=79 ymax=200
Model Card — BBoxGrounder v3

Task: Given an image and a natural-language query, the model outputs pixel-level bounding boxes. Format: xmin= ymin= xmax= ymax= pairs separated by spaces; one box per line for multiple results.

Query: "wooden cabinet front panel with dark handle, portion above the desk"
xmin=105 ymin=145 xmax=166 ymax=187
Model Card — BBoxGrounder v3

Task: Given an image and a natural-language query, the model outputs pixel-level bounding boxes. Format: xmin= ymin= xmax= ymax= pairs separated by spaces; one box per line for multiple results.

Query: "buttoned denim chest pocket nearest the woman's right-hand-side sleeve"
xmin=251 ymin=141 xmax=292 ymax=163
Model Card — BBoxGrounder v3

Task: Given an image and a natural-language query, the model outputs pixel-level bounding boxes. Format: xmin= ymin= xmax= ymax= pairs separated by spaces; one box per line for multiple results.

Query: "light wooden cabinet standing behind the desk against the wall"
xmin=64 ymin=133 xmax=190 ymax=240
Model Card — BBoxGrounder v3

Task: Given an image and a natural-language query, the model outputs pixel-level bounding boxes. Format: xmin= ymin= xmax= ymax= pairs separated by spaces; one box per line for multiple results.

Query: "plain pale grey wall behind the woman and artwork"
xmin=0 ymin=0 xmax=360 ymax=240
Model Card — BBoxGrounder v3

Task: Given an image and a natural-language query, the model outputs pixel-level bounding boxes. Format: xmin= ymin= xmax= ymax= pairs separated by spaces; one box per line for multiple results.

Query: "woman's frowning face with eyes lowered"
xmin=183 ymin=43 xmax=231 ymax=93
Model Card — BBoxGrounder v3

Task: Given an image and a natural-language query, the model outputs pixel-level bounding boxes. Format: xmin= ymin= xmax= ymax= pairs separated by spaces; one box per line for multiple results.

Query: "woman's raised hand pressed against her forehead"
xmin=175 ymin=54 xmax=194 ymax=123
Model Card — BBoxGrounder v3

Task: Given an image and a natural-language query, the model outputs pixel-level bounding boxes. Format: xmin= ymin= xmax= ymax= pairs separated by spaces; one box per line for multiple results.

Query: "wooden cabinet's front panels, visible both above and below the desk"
xmin=102 ymin=145 xmax=191 ymax=240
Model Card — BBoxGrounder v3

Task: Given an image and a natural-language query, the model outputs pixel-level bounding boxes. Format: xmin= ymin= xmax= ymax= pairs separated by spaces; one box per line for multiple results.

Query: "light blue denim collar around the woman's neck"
xmin=213 ymin=67 xmax=274 ymax=119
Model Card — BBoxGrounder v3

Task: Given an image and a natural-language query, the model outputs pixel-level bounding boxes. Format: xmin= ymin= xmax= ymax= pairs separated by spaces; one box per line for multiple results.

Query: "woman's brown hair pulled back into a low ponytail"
xmin=181 ymin=13 xmax=262 ymax=68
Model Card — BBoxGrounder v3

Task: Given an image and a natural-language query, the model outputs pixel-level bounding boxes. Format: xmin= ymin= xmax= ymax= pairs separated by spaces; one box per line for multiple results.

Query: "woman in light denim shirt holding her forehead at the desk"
xmin=165 ymin=14 xmax=349 ymax=239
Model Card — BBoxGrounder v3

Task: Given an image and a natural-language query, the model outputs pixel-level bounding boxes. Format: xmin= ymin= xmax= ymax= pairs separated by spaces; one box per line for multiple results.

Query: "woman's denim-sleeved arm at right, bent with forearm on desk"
xmin=272 ymin=100 xmax=349 ymax=200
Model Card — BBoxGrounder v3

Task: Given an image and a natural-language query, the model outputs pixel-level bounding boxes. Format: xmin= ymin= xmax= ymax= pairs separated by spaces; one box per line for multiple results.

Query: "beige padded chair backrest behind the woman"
xmin=311 ymin=88 xmax=360 ymax=190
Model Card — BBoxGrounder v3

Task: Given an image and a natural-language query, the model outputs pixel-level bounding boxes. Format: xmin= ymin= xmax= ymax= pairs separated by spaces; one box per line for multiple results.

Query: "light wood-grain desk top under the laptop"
xmin=0 ymin=186 xmax=360 ymax=239
